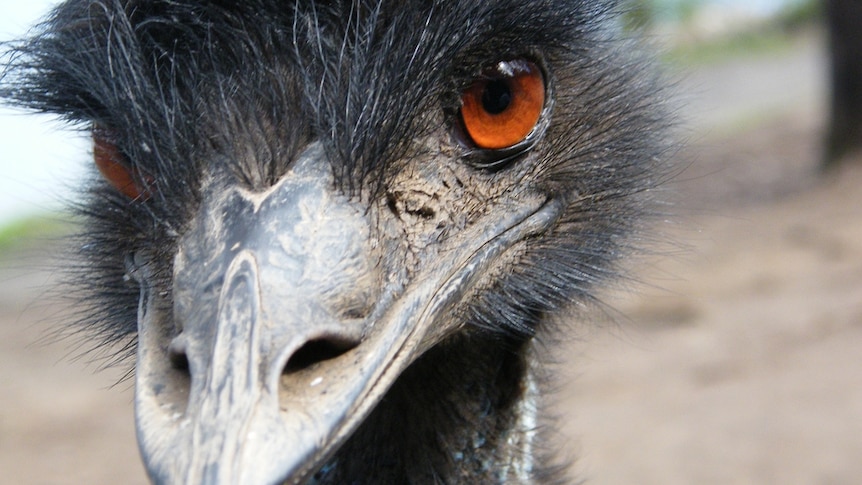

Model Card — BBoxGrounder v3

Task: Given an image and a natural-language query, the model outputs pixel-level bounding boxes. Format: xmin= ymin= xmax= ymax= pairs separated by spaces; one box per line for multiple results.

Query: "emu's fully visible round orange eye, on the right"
xmin=461 ymin=60 xmax=545 ymax=150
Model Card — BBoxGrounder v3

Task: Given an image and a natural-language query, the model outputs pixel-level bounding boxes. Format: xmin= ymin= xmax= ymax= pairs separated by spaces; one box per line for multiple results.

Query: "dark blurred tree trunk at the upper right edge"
xmin=825 ymin=0 xmax=862 ymax=168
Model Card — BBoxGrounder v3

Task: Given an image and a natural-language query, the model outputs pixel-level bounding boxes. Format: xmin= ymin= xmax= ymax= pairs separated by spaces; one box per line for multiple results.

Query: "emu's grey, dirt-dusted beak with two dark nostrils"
xmin=128 ymin=145 xmax=561 ymax=484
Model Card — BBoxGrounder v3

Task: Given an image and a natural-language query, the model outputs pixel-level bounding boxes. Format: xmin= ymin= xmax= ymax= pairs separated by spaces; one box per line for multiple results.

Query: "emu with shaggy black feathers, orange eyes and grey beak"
xmin=2 ymin=0 xmax=669 ymax=484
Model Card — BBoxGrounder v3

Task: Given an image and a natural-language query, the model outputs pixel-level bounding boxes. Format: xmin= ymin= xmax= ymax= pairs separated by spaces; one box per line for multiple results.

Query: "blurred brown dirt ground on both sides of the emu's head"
xmin=0 ymin=36 xmax=862 ymax=485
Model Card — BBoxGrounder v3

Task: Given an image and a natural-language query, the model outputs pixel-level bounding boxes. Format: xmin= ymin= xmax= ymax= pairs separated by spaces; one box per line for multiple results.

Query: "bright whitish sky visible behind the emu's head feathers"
xmin=0 ymin=0 xmax=794 ymax=226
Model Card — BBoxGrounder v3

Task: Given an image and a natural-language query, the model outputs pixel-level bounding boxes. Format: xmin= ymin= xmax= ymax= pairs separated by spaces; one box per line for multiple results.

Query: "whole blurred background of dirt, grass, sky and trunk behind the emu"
xmin=0 ymin=0 xmax=862 ymax=485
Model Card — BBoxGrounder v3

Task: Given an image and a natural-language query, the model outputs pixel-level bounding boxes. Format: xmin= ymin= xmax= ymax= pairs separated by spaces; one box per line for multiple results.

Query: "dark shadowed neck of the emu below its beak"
xmin=311 ymin=332 xmax=537 ymax=484
